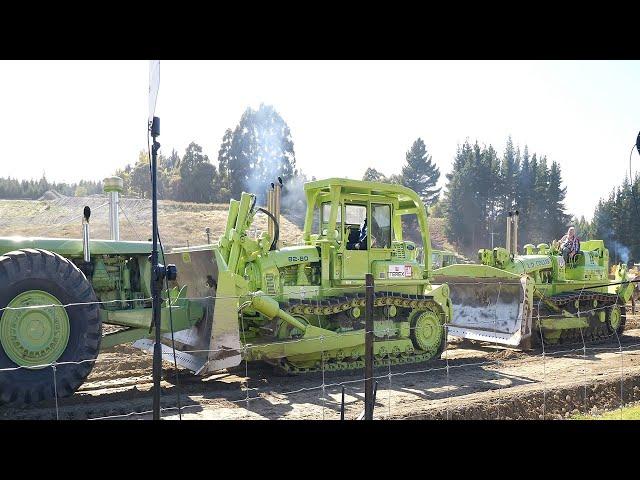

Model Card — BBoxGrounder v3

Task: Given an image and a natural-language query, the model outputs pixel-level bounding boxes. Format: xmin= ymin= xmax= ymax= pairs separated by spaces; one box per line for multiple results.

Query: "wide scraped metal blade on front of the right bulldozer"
xmin=437 ymin=275 xmax=531 ymax=347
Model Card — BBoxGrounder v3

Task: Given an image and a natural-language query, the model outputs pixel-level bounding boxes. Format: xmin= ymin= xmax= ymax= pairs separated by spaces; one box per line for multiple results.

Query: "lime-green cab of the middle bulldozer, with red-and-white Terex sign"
xmin=303 ymin=179 xmax=431 ymax=284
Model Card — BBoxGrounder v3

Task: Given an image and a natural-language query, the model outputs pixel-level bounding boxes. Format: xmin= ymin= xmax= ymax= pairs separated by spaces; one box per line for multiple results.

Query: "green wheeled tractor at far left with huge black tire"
xmin=0 ymin=177 xmax=205 ymax=404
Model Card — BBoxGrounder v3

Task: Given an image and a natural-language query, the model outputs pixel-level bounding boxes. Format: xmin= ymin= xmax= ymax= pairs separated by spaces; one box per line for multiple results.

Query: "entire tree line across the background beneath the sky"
xmin=0 ymin=104 xmax=604 ymax=264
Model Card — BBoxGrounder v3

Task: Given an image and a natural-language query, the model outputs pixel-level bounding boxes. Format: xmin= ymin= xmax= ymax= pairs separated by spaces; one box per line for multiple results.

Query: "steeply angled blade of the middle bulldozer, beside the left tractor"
xmin=165 ymin=246 xmax=242 ymax=374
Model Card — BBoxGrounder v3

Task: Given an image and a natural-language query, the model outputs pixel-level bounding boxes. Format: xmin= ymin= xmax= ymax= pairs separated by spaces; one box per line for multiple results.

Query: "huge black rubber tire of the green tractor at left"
xmin=0 ymin=249 xmax=102 ymax=405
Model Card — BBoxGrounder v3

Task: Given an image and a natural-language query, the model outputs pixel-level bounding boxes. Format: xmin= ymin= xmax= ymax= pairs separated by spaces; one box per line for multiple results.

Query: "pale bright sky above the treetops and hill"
xmin=0 ymin=61 xmax=640 ymax=218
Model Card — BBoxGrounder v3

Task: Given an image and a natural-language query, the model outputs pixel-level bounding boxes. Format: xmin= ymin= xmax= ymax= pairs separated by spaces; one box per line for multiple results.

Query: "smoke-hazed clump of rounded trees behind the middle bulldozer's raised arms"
xmin=115 ymin=104 xmax=306 ymax=203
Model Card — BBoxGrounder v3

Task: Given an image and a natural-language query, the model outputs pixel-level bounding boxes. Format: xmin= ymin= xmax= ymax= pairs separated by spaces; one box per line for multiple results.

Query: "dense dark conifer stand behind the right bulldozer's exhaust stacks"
xmin=442 ymin=137 xmax=571 ymax=252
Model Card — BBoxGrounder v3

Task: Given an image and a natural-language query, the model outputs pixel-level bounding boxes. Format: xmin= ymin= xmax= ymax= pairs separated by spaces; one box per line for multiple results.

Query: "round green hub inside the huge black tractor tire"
xmin=0 ymin=290 xmax=70 ymax=367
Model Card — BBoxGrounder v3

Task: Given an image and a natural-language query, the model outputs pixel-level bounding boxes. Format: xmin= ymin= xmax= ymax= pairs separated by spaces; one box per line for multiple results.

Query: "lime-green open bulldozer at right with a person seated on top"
xmin=434 ymin=211 xmax=634 ymax=349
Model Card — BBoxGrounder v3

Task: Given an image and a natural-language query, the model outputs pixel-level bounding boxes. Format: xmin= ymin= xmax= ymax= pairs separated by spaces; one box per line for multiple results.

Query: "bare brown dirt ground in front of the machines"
xmin=0 ymin=308 xmax=640 ymax=419
